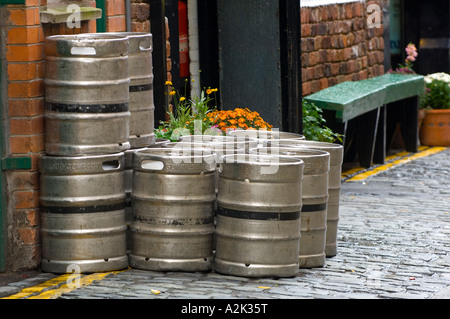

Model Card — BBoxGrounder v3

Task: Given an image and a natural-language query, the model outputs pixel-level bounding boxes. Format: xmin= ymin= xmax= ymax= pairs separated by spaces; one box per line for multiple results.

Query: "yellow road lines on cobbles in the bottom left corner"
xmin=0 ymin=269 xmax=127 ymax=299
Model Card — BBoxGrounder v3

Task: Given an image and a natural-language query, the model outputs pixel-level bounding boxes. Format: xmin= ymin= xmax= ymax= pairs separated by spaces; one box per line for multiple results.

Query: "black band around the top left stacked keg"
xmin=45 ymin=102 xmax=129 ymax=113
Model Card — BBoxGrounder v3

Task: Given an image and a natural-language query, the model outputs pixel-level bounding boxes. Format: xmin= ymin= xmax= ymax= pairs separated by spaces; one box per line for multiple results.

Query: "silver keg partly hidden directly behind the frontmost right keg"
xmin=250 ymin=147 xmax=330 ymax=268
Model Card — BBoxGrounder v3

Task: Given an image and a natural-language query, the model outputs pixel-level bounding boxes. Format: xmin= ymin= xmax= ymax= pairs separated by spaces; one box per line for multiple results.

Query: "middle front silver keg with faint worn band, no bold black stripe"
xmin=130 ymin=148 xmax=216 ymax=271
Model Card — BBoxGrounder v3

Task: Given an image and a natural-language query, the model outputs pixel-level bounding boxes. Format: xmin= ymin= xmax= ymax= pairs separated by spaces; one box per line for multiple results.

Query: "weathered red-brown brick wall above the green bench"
xmin=301 ymin=0 xmax=384 ymax=96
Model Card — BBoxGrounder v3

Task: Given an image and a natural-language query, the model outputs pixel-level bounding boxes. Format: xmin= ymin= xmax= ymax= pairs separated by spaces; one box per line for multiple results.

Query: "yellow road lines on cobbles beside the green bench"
xmin=342 ymin=146 xmax=447 ymax=182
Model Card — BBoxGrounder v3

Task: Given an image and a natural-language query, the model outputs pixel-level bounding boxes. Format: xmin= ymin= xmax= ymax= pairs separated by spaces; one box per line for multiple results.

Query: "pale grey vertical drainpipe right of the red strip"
xmin=187 ymin=0 xmax=201 ymax=97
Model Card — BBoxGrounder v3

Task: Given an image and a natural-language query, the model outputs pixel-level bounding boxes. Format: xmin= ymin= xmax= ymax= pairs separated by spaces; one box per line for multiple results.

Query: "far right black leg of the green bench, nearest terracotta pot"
xmin=401 ymin=96 xmax=419 ymax=153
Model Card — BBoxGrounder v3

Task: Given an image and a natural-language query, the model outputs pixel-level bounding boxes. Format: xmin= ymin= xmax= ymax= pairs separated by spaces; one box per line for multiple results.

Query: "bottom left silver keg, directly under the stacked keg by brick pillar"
xmin=39 ymin=153 xmax=128 ymax=273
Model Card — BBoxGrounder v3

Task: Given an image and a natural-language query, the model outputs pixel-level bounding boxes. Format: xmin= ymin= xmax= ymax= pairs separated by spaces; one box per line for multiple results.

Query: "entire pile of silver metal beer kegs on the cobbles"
xmin=40 ymin=33 xmax=342 ymax=277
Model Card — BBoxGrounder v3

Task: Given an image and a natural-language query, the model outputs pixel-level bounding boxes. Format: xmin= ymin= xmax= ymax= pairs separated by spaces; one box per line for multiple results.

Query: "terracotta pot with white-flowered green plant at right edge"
xmin=419 ymin=72 xmax=450 ymax=146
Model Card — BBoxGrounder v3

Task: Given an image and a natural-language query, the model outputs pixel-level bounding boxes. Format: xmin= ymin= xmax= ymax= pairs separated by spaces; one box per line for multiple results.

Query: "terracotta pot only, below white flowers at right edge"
xmin=420 ymin=109 xmax=450 ymax=146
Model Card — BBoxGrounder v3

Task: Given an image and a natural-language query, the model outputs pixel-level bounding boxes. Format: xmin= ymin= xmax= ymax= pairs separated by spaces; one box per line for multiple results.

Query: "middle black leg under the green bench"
xmin=356 ymin=107 xmax=380 ymax=167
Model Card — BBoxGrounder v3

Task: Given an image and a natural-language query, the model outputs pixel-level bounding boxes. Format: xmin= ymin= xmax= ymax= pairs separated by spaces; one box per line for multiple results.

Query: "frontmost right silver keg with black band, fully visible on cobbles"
xmin=213 ymin=154 xmax=303 ymax=277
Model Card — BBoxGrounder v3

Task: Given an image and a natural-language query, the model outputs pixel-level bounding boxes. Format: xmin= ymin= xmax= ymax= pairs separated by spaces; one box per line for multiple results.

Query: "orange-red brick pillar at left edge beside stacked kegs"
xmin=1 ymin=0 xmax=46 ymax=270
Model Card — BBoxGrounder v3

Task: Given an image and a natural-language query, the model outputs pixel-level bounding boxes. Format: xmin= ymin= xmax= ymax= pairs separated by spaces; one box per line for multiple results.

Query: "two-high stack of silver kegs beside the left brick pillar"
xmin=40 ymin=33 xmax=155 ymax=273
